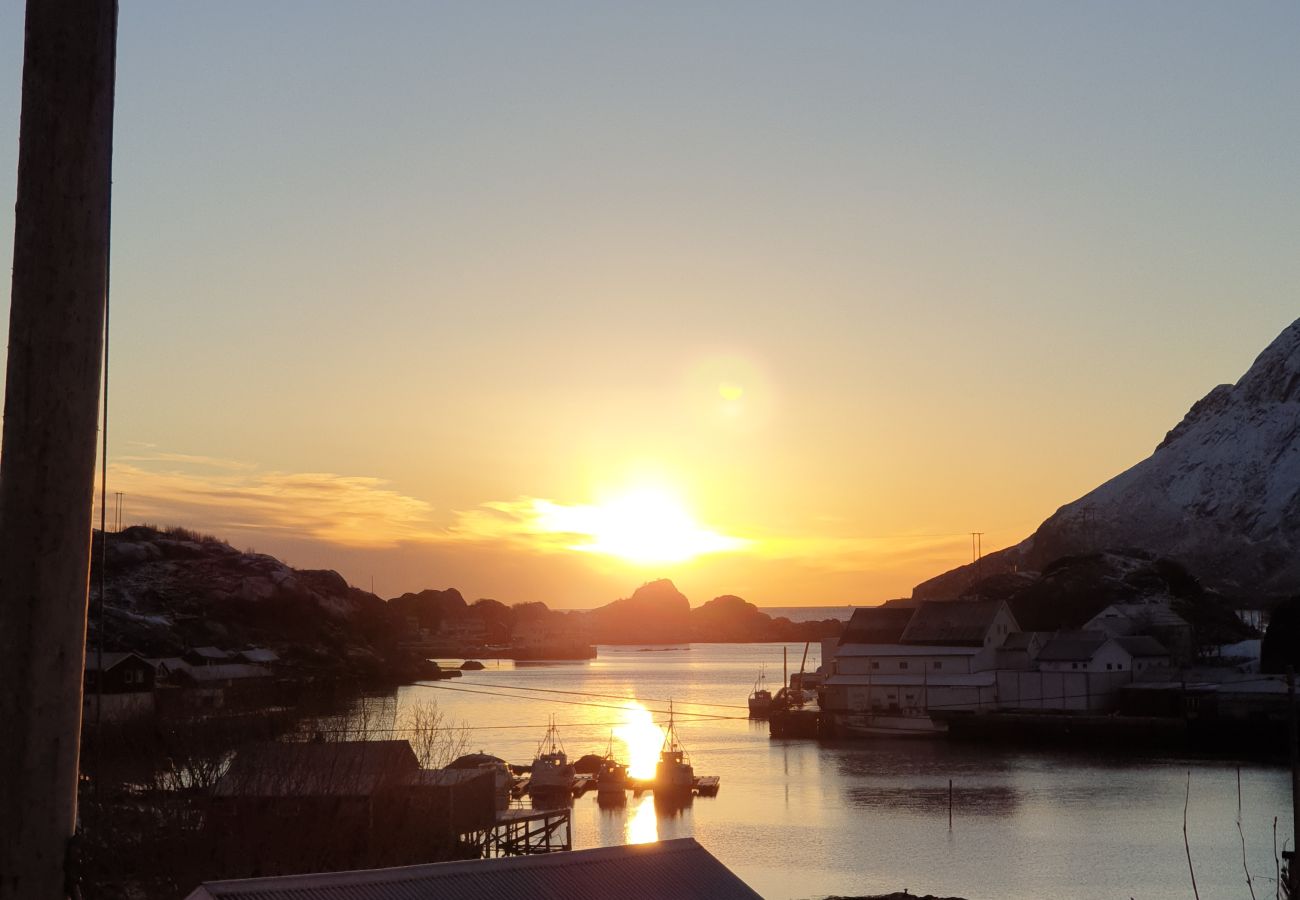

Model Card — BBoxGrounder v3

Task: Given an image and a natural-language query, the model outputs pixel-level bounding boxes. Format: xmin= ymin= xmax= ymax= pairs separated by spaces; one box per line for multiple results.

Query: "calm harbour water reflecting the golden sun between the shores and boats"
xmin=398 ymin=644 xmax=1291 ymax=900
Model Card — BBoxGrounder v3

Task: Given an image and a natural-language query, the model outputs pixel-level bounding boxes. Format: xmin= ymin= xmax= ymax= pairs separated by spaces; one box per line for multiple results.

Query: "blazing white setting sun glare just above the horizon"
xmin=538 ymin=486 xmax=746 ymax=564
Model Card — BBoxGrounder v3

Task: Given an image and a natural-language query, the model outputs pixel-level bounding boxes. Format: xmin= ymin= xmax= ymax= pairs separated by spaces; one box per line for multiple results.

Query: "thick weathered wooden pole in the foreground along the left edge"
xmin=0 ymin=0 xmax=117 ymax=900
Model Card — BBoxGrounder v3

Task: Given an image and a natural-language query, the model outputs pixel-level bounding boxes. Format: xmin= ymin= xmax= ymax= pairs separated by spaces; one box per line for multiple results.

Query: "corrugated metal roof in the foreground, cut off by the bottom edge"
xmin=179 ymin=838 xmax=759 ymax=900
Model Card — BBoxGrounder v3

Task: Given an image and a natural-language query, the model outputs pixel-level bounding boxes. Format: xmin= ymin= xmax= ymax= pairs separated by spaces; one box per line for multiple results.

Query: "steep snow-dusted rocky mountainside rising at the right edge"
xmin=913 ymin=320 xmax=1300 ymax=600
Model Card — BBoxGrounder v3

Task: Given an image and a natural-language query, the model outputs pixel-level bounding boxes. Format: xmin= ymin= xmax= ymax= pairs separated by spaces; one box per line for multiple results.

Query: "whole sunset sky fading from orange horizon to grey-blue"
xmin=0 ymin=0 xmax=1300 ymax=609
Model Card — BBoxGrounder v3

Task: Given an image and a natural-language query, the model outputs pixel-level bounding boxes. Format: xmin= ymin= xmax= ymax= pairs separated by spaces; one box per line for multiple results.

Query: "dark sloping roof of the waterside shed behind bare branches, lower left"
xmin=212 ymin=740 xmax=420 ymax=797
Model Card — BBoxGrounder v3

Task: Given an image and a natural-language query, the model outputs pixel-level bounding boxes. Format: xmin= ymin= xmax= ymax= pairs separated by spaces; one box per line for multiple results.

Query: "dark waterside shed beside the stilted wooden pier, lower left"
xmin=207 ymin=740 xmax=497 ymax=874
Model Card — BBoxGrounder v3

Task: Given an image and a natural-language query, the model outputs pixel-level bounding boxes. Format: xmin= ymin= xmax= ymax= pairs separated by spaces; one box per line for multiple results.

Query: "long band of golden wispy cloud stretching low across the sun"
xmin=109 ymin=451 xmax=1003 ymax=572
